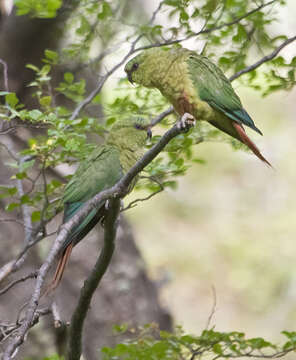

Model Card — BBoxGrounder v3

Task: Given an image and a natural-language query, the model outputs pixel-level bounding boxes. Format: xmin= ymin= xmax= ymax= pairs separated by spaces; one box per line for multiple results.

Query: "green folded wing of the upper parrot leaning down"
xmin=187 ymin=53 xmax=262 ymax=135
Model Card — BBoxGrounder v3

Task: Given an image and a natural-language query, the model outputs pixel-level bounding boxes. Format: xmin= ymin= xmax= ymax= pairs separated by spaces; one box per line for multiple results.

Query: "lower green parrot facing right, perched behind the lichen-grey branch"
xmin=46 ymin=119 xmax=151 ymax=293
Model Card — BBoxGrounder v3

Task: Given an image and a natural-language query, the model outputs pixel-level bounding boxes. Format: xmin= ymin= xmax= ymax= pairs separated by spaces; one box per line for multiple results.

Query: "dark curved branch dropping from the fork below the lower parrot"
xmin=67 ymin=199 xmax=120 ymax=360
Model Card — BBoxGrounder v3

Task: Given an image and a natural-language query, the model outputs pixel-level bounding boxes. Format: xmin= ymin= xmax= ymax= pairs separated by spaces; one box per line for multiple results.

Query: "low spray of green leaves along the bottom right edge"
xmin=101 ymin=324 xmax=296 ymax=360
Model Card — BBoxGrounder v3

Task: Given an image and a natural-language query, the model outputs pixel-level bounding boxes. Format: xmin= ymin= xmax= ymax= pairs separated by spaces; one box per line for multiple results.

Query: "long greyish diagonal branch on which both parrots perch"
xmin=3 ymin=119 xmax=194 ymax=360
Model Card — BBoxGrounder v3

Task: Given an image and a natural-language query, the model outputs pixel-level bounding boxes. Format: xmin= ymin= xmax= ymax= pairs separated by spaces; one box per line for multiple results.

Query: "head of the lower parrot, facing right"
xmin=107 ymin=117 xmax=152 ymax=149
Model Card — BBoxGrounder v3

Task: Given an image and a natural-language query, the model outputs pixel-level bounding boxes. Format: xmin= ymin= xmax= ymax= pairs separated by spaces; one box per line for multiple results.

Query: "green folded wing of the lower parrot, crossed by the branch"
xmin=63 ymin=145 xmax=123 ymax=249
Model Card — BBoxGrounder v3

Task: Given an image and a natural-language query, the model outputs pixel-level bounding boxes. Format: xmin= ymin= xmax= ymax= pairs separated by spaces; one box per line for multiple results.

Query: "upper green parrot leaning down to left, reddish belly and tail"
xmin=124 ymin=48 xmax=271 ymax=166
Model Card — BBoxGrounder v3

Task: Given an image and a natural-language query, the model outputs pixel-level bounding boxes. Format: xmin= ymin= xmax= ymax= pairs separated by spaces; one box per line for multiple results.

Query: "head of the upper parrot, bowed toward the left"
xmin=124 ymin=48 xmax=170 ymax=87
